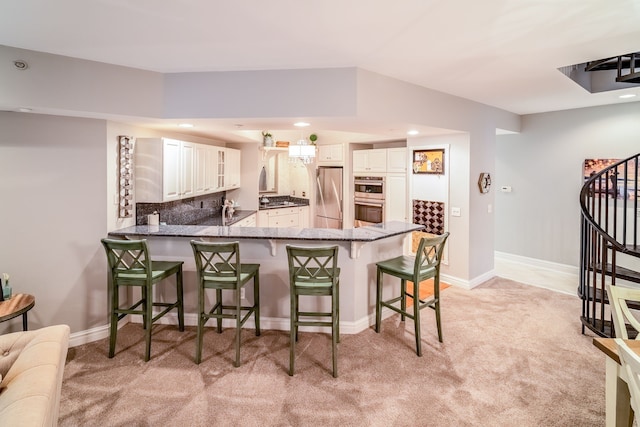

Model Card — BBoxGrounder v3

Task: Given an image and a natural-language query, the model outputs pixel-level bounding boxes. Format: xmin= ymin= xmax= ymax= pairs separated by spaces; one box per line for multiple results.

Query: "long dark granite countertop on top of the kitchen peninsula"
xmin=109 ymin=222 xmax=424 ymax=242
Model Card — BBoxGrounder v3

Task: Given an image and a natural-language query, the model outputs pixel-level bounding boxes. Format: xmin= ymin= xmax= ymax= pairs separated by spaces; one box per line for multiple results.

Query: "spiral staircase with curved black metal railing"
xmin=578 ymin=153 xmax=640 ymax=337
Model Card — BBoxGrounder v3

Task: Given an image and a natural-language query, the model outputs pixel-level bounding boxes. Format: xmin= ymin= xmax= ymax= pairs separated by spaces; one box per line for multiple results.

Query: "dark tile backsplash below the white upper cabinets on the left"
xmin=136 ymin=192 xmax=225 ymax=225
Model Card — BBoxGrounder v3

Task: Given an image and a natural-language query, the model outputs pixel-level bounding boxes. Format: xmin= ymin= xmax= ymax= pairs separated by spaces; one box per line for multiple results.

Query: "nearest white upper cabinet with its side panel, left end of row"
xmin=135 ymin=138 xmax=195 ymax=203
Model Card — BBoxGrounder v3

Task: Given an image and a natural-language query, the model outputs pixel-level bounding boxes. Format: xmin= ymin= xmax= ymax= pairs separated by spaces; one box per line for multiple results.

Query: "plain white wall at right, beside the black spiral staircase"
xmin=493 ymin=102 xmax=640 ymax=266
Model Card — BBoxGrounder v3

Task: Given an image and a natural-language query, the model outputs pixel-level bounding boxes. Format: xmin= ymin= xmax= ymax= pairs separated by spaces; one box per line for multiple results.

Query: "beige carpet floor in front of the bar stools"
xmin=60 ymin=278 xmax=605 ymax=427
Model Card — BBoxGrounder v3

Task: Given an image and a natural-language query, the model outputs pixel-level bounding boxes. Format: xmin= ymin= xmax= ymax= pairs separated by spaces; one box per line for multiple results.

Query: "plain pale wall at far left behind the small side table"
xmin=0 ymin=112 xmax=107 ymax=333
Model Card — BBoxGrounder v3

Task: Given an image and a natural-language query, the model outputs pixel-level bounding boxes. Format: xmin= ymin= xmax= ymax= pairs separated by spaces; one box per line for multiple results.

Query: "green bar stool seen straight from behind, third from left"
xmin=287 ymin=245 xmax=340 ymax=378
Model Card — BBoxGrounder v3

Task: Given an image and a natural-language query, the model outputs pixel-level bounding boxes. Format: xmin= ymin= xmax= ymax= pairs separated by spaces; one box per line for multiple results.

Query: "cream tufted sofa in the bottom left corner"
xmin=0 ymin=325 xmax=69 ymax=426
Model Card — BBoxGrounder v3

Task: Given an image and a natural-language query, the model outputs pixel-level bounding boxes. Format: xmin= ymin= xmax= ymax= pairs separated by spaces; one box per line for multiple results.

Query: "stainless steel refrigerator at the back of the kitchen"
xmin=314 ymin=166 xmax=342 ymax=229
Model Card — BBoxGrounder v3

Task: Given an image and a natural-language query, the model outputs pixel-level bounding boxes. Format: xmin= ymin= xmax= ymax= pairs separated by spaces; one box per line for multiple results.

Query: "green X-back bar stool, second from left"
xmin=191 ymin=240 xmax=260 ymax=367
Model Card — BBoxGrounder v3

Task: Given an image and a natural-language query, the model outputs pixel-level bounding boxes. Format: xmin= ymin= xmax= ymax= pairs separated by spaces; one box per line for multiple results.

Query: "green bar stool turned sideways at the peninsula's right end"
xmin=376 ymin=232 xmax=449 ymax=356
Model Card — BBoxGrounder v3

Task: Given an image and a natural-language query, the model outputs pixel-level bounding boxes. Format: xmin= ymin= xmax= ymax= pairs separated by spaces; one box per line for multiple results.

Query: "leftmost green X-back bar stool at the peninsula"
xmin=101 ymin=239 xmax=184 ymax=362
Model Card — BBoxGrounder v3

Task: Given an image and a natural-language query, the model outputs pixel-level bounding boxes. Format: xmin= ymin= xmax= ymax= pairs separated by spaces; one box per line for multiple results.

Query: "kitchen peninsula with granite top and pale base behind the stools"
xmin=109 ymin=221 xmax=423 ymax=333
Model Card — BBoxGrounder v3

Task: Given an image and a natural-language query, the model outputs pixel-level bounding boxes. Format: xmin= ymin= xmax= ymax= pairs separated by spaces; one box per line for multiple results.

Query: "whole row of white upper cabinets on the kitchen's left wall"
xmin=135 ymin=138 xmax=240 ymax=203
